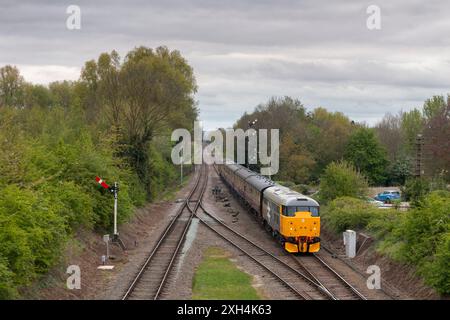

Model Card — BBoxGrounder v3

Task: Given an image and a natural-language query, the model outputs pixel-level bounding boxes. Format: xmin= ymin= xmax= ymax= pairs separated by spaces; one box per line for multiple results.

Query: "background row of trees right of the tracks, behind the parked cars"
xmin=235 ymin=96 xmax=450 ymax=185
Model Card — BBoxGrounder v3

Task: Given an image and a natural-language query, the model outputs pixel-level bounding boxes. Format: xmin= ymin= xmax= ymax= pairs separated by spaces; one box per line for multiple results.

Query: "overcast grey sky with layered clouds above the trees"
xmin=0 ymin=0 xmax=450 ymax=129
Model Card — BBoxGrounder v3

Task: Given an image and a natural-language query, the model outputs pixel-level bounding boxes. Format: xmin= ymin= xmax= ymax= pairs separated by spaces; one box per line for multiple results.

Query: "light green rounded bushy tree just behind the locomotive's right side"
xmin=319 ymin=161 xmax=367 ymax=204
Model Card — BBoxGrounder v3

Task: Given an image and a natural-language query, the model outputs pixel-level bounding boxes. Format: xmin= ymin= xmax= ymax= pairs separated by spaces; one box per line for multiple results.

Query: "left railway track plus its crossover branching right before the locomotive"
xmin=122 ymin=165 xmax=365 ymax=300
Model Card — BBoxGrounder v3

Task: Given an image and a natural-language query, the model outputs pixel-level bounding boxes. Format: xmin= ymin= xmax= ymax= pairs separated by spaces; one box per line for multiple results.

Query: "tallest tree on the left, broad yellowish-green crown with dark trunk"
xmin=81 ymin=47 xmax=198 ymax=194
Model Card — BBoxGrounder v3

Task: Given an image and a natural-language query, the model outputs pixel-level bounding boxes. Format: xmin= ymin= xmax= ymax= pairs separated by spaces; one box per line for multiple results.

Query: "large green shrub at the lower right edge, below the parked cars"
xmin=379 ymin=191 xmax=450 ymax=294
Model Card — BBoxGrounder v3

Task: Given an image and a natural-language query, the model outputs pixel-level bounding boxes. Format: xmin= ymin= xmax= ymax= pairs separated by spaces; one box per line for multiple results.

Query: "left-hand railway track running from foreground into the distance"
xmin=122 ymin=165 xmax=208 ymax=300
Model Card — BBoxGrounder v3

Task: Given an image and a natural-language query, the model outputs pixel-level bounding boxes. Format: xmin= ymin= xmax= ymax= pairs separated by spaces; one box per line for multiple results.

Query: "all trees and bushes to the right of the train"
xmin=235 ymin=96 xmax=450 ymax=295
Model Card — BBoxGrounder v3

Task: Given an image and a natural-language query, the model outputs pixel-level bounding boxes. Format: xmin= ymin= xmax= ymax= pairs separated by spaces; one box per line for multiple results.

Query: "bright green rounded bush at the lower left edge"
xmin=0 ymin=185 xmax=66 ymax=298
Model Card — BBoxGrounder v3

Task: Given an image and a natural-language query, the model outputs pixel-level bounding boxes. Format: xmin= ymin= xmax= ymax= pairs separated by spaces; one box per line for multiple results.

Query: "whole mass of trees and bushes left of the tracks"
xmin=0 ymin=47 xmax=198 ymax=298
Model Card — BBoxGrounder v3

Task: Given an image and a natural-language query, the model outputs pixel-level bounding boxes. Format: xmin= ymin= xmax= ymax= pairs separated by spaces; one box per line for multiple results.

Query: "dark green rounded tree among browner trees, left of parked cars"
xmin=344 ymin=128 xmax=389 ymax=184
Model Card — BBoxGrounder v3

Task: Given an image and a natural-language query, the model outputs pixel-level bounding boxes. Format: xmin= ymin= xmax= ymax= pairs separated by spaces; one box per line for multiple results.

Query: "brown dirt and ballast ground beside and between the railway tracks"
xmin=24 ymin=167 xmax=436 ymax=299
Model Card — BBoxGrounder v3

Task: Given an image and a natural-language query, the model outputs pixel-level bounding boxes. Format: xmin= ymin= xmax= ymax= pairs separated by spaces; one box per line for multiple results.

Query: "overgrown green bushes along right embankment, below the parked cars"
xmin=322 ymin=191 xmax=450 ymax=295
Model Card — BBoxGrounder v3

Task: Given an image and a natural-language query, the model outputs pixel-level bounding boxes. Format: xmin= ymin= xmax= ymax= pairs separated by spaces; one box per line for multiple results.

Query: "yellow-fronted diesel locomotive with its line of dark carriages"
xmin=216 ymin=161 xmax=320 ymax=253
